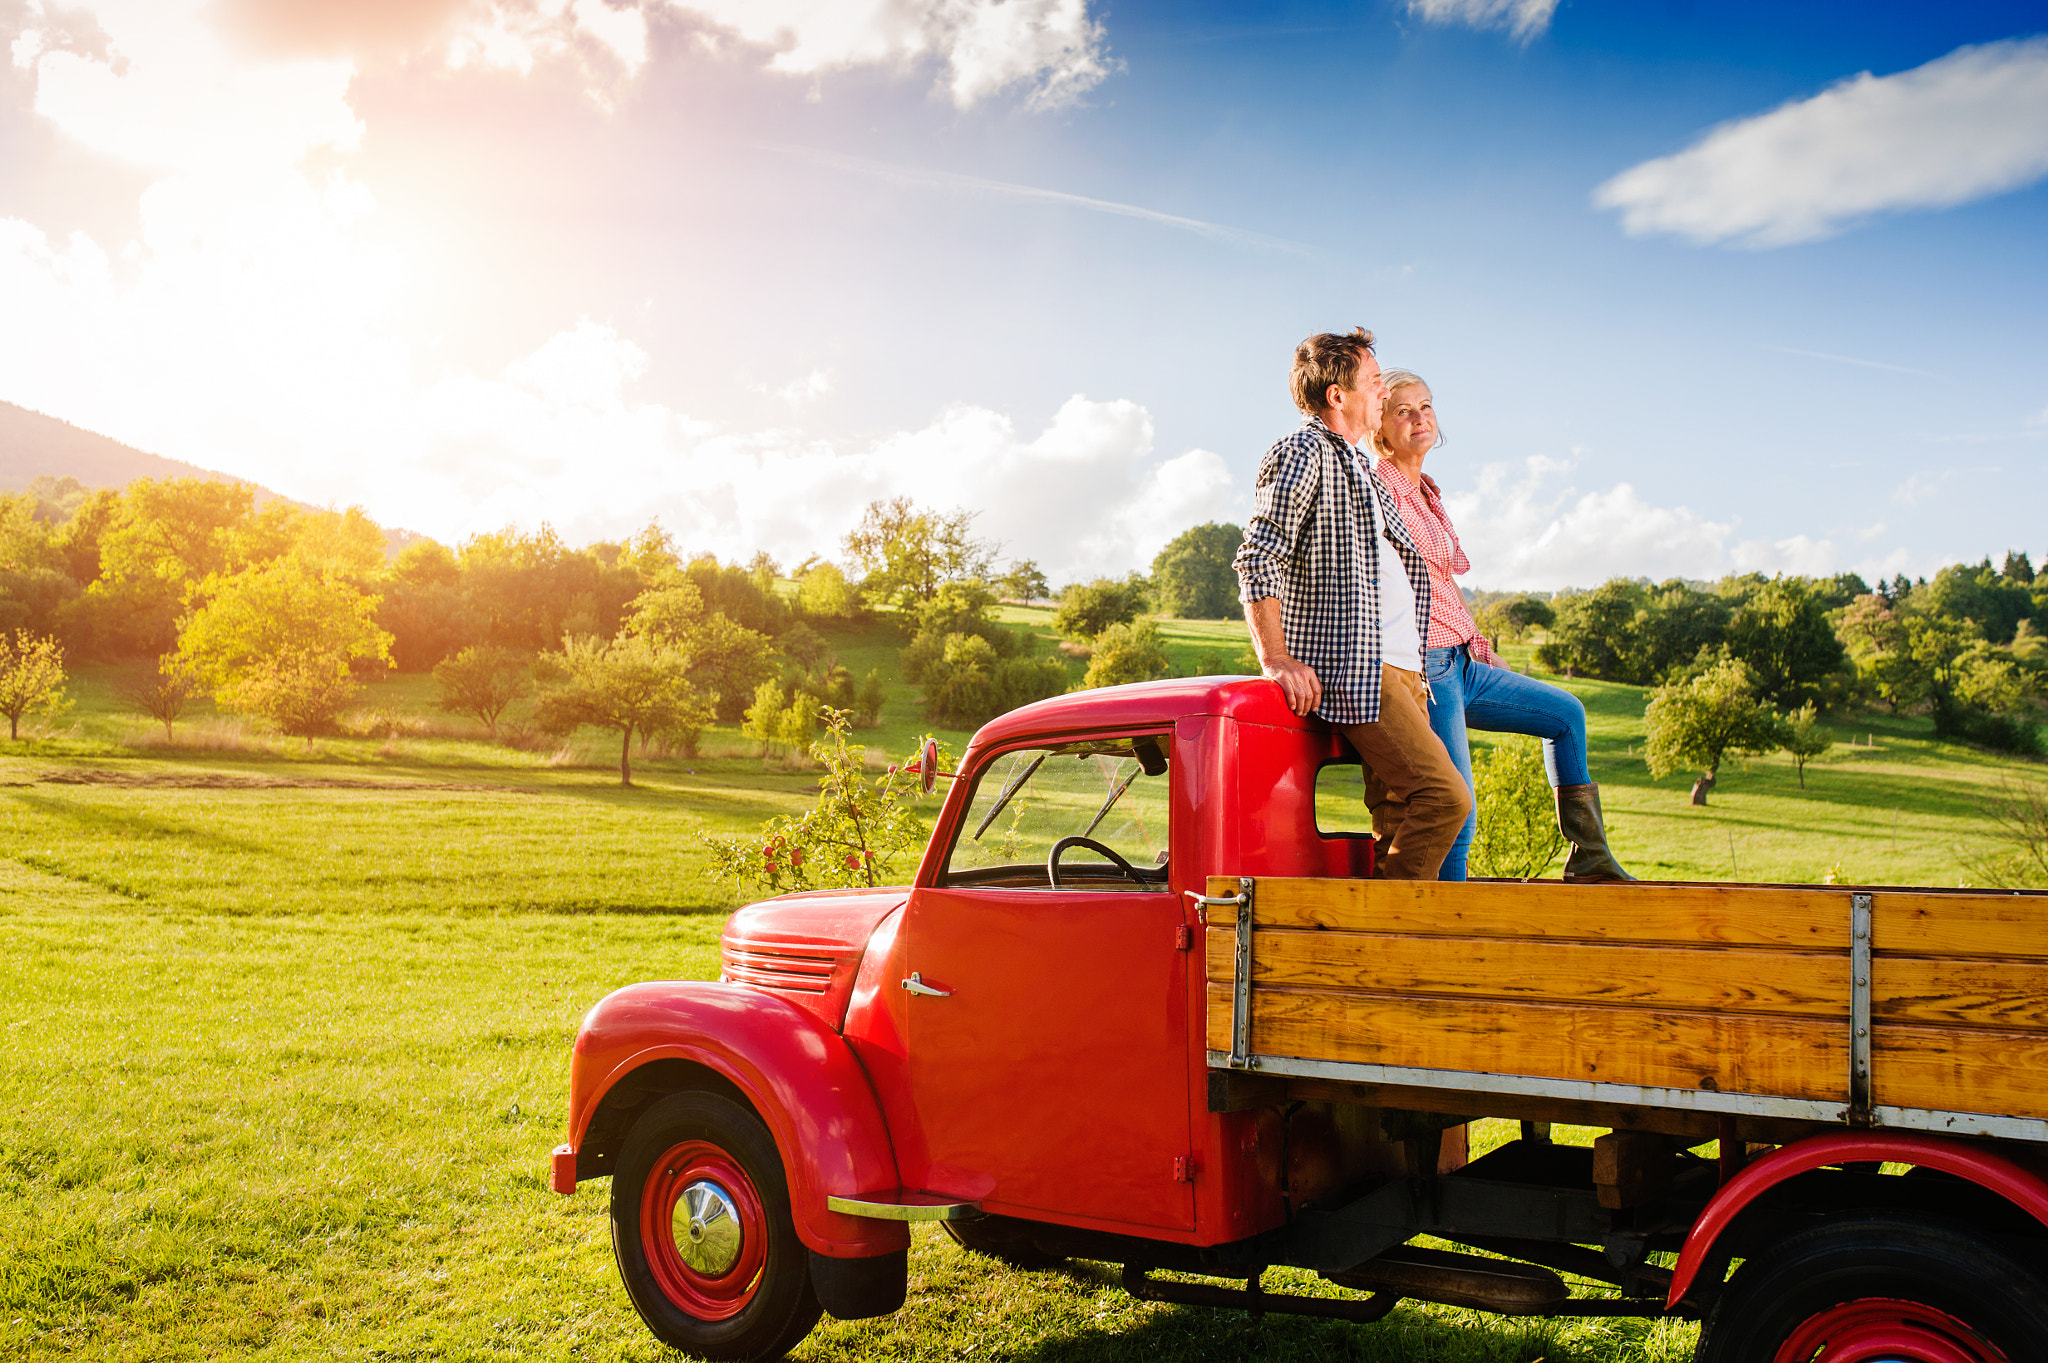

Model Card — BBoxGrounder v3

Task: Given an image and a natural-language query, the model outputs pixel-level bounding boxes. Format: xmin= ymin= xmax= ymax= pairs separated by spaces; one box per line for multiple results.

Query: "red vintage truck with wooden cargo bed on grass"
xmin=553 ymin=677 xmax=2048 ymax=1363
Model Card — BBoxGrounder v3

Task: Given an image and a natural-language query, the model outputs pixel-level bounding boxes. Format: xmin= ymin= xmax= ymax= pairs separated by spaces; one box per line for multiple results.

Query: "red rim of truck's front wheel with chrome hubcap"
xmin=641 ymin=1140 xmax=768 ymax=1320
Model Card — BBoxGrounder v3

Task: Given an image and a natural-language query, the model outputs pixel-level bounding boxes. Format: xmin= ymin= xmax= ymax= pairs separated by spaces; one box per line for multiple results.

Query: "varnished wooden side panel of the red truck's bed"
xmin=1206 ymin=876 xmax=2048 ymax=1142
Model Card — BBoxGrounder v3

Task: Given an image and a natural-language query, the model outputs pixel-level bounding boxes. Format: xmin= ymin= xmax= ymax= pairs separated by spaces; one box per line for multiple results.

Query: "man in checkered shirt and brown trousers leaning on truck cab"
xmin=1233 ymin=327 xmax=1473 ymax=880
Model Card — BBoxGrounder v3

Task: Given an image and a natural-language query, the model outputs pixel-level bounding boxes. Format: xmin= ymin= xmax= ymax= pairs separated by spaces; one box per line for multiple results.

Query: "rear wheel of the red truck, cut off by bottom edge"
xmin=1694 ymin=1212 xmax=2048 ymax=1363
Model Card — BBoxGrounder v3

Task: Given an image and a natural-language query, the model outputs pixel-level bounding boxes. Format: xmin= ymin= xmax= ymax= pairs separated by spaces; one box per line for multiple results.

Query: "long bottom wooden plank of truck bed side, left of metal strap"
xmin=1206 ymin=980 xmax=1849 ymax=1101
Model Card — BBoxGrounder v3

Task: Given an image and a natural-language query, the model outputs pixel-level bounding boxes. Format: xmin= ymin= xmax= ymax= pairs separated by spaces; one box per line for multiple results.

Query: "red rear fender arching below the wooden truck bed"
xmin=1665 ymin=1132 xmax=2048 ymax=1310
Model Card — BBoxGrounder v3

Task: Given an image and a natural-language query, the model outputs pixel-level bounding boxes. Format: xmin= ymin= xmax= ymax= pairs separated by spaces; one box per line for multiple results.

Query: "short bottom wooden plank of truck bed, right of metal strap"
xmin=1875 ymin=1013 xmax=2048 ymax=1117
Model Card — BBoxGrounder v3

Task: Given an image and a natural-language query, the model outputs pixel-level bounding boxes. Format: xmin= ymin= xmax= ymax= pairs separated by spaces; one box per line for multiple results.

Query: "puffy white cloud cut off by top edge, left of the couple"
xmin=668 ymin=0 xmax=1118 ymax=108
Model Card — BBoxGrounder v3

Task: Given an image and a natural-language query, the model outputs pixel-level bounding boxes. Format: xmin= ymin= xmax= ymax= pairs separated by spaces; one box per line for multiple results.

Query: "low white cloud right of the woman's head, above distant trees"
xmin=1444 ymin=454 xmax=1839 ymax=591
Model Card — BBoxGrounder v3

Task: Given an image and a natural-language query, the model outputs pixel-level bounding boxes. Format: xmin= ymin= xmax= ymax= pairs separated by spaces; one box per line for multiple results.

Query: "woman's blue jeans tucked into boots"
xmin=1421 ymin=645 xmax=1593 ymax=880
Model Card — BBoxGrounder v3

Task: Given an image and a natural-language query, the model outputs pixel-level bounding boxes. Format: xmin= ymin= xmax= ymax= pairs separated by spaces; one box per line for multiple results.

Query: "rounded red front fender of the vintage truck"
xmin=555 ymin=980 xmax=909 ymax=1259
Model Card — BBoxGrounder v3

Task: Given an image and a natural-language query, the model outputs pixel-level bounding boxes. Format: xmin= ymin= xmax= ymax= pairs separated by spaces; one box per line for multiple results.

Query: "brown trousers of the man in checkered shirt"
xmin=1343 ymin=665 xmax=1473 ymax=880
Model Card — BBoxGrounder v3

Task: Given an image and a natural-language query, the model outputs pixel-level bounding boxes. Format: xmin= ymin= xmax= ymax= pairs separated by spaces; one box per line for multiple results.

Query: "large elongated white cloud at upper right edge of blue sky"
xmin=1593 ymin=37 xmax=2048 ymax=248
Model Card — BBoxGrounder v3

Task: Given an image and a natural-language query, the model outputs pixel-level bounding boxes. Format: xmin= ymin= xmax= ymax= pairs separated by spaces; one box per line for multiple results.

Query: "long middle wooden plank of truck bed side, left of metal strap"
xmin=1204 ymin=927 xmax=1849 ymax=1019
